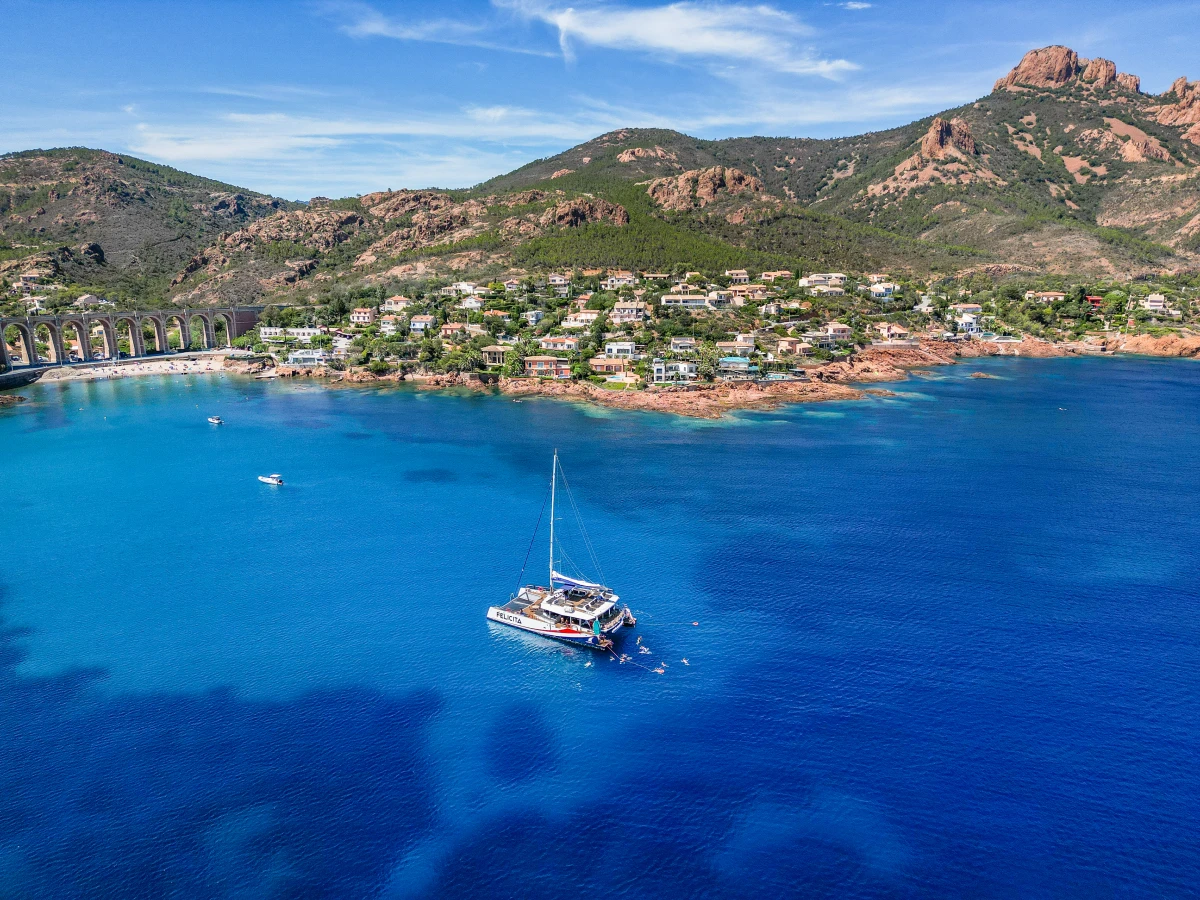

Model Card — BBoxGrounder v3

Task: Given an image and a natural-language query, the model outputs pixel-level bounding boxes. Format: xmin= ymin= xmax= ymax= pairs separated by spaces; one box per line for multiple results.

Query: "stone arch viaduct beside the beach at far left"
xmin=0 ymin=306 xmax=263 ymax=372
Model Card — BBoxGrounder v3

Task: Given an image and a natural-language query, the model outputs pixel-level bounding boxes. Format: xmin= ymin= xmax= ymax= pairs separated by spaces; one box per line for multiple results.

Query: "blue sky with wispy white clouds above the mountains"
xmin=0 ymin=0 xmax=1200 ymax=199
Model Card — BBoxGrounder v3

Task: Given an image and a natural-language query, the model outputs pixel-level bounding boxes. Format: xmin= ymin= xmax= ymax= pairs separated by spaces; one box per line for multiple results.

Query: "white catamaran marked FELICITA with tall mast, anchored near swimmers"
xmin=487 ymin=450 xmax=637 ymax=650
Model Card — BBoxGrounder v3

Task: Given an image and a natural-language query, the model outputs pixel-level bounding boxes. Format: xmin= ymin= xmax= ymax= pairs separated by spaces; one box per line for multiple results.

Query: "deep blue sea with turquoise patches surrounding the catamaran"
xmin=0 ymin=359 xmax=1200 ymax=900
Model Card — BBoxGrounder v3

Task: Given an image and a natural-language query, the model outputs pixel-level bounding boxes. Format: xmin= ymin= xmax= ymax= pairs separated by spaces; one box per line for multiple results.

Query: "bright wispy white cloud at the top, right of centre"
xmin=501 ymin=0 xmax=857 ymax=78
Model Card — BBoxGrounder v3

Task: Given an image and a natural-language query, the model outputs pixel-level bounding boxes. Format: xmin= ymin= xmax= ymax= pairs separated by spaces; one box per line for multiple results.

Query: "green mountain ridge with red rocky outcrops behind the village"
xmin=0 ymin=46 xmax=1200 ymax=304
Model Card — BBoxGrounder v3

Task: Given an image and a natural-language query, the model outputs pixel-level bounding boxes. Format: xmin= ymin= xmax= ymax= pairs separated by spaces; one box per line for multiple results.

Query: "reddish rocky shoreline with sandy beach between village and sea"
xmin=4 ymin=335 xmax=1200 ymax=419
